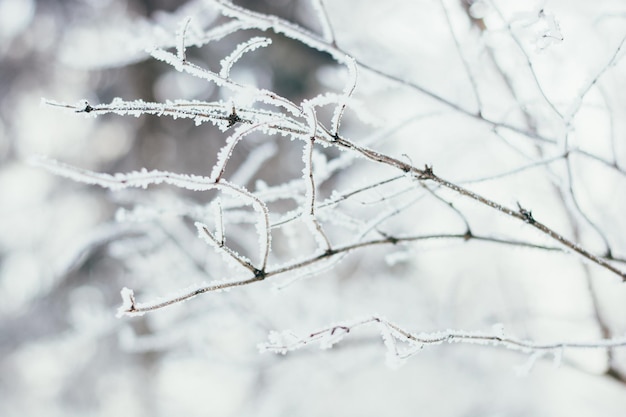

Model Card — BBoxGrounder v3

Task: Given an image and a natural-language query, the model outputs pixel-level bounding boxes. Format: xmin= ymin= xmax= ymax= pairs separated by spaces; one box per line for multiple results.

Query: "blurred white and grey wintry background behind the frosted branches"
xmin=0 ymin=0 xmax=626 ymax=417
